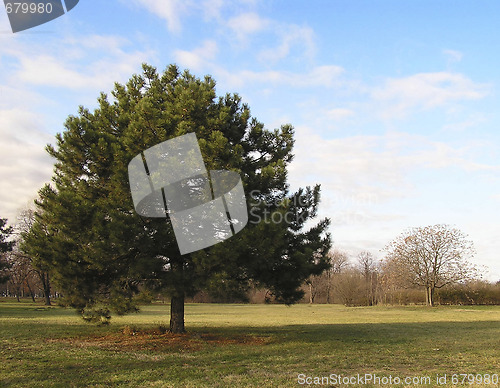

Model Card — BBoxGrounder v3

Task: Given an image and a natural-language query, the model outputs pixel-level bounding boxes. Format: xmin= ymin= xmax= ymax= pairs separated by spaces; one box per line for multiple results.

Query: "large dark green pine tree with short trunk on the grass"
xmin=24 ymin=65 xmax=330 ymax=332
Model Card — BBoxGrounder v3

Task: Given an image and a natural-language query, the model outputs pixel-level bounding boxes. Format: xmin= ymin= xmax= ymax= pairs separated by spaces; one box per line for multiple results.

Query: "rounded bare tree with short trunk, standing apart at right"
xmin=384 ymin=225 xmax=477 ymax=306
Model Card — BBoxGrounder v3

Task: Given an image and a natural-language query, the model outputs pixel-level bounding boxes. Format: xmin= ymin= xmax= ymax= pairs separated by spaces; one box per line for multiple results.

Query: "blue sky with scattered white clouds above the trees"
xmin=0 ymin=0 xmax=500 ymax=280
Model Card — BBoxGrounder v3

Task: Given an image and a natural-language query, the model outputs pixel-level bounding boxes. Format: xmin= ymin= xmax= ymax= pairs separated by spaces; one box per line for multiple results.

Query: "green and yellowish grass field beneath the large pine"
xmin=0 ymin=301 xmax=500 ymax=387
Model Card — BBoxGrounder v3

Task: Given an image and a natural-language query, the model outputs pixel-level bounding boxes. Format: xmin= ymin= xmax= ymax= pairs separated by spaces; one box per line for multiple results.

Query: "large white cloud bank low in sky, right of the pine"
xmin=289 ymin=127 xmax=500 ymax=274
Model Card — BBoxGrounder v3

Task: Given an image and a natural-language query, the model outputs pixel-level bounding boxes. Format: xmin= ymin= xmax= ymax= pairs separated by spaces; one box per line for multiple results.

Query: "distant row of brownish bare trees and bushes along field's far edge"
xmin=0 ymin=246 xmax=500 ymax=306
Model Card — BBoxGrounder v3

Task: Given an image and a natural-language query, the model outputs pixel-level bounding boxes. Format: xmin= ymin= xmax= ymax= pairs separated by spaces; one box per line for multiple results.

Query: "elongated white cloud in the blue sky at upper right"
xmin=371 ymin=72 xmax=488 ymax=119
